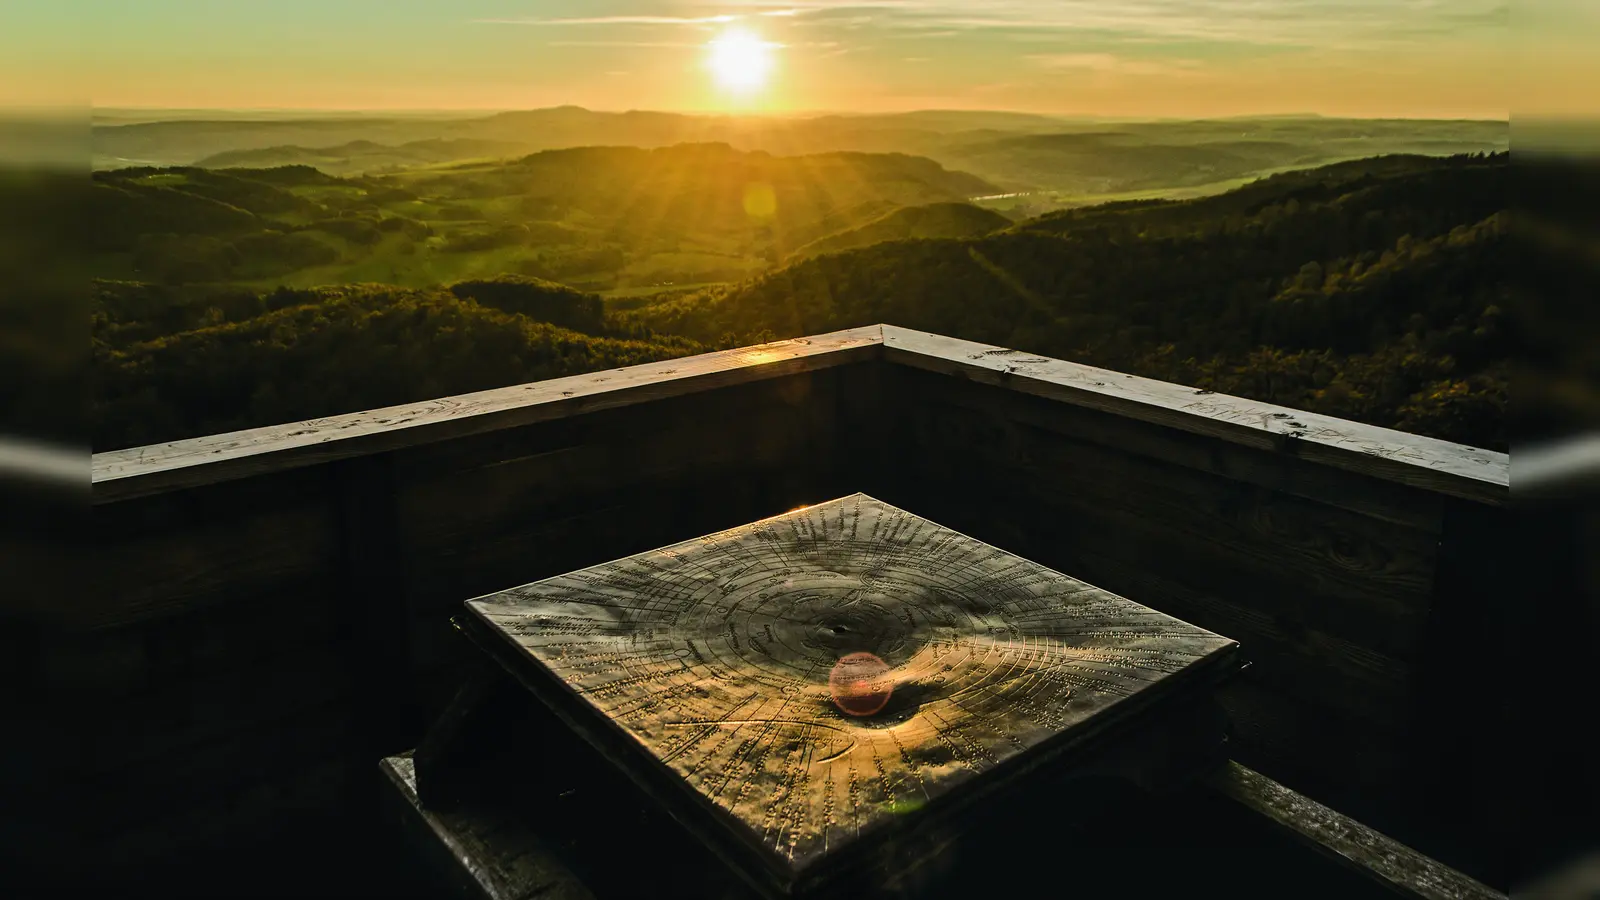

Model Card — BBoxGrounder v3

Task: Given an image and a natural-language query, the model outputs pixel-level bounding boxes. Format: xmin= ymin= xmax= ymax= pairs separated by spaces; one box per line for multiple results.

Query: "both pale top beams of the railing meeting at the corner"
xmin=91 ymin=325 xmax=1510 ymax=506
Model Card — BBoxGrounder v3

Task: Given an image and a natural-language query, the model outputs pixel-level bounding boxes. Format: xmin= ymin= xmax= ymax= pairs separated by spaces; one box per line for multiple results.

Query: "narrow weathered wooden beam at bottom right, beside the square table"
xmin=1208 ymin=762 xmax=1506 ymax=900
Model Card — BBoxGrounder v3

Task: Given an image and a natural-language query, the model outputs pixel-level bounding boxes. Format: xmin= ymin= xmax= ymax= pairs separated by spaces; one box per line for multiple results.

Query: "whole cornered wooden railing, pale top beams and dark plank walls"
xmin=81 ymin=325 xmax=1509 ymax=881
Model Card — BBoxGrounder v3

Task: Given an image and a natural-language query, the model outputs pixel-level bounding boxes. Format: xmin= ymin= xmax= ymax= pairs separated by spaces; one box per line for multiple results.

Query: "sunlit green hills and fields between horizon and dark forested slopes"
xmin=90 ymin=109 xmax=1509 ymax=298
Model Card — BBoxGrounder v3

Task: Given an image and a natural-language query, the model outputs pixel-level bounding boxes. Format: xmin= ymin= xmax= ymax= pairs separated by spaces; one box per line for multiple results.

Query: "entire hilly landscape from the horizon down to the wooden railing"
xmin=88 ymin=107 xmax=1514 ymax=448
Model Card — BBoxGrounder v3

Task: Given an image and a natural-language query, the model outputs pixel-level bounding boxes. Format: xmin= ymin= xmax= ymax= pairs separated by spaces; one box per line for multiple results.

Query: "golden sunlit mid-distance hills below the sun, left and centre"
xmin=90 ymin=144 xmax=995 ymax=290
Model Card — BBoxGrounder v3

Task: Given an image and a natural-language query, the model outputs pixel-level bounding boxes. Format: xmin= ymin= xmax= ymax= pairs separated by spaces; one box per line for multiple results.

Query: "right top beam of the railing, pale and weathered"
xmin=883 ymin=325 xmax=1510 ymax=504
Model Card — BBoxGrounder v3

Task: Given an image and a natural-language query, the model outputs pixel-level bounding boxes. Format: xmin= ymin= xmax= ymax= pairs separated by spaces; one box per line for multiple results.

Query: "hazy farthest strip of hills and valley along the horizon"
xmin=91 ymin=106 xmax=1510 ymax=215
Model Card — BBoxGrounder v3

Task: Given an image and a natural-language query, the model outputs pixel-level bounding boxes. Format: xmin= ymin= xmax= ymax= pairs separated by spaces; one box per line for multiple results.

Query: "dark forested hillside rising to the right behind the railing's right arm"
xmin=632 ymin=154 xmax=1512 ymax=448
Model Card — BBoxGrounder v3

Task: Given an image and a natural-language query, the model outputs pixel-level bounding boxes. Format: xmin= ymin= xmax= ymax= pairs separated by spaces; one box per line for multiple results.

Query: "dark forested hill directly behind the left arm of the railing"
xmin=91 ymin=277 xmax=713 ymax=452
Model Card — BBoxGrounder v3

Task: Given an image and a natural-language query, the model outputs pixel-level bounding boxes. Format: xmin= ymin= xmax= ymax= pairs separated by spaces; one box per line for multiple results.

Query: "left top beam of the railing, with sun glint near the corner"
xmin=93 ymin=325 xmax=882 ymax=503
